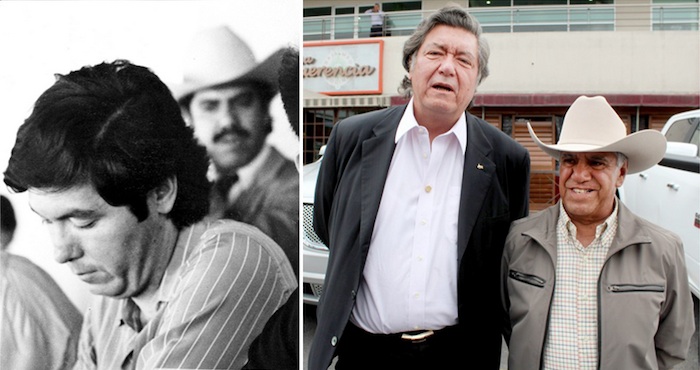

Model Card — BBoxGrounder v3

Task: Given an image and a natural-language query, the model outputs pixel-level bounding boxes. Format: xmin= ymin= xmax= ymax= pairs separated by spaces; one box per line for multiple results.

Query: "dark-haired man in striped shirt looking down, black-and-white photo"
xmin=4 ymin=60 xmax=296 ymax=369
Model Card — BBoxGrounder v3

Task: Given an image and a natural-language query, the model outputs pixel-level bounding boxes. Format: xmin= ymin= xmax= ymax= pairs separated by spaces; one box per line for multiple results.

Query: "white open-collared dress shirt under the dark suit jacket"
xmin=352 ymin=100 xmax=467 ymax=334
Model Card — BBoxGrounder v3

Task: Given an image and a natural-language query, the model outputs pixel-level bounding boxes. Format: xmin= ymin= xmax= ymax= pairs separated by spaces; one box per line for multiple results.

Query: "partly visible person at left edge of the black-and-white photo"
xmin=0 ymin=195 xmax=83 ymax=370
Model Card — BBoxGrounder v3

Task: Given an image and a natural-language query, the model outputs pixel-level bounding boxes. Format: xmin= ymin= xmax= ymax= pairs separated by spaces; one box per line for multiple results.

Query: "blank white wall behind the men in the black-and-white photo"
xmin=0 ymin=0 xmax=302 ymax=310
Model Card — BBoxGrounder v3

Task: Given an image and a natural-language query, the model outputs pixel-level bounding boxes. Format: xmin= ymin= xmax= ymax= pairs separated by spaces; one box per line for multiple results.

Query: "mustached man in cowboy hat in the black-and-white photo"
xmin=172 ymin=26 xmax=299 ymax=276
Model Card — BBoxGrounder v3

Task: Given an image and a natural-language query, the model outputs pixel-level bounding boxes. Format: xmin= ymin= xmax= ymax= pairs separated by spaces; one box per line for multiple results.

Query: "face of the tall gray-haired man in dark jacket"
xmin=409 ymin=25 xmax=479 ymax=129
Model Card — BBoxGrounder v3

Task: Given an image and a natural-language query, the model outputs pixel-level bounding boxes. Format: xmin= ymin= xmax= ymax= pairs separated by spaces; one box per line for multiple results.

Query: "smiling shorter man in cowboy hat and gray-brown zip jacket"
xmin=501 ymin=96 xmax=694 ymax=370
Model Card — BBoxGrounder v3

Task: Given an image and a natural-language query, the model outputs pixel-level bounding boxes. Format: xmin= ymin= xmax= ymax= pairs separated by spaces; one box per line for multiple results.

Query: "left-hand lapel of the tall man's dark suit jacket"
xmin=360 ymin=106 xmax=405 ymax=253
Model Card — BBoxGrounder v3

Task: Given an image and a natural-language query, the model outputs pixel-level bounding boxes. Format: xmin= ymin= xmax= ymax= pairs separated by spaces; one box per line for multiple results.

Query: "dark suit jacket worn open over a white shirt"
xmin=309 ymin=106 xmax=530 ymax=370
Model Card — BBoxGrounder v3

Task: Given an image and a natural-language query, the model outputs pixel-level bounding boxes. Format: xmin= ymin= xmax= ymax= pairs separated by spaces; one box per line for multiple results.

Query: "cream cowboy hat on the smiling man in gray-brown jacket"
xmin=527 ymin=96 xmax=666 ymax=173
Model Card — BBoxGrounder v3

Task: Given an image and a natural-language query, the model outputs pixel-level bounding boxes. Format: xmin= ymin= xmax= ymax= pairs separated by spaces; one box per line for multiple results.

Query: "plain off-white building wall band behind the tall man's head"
xmin=383 ymin=31 xmax=700 ymax=95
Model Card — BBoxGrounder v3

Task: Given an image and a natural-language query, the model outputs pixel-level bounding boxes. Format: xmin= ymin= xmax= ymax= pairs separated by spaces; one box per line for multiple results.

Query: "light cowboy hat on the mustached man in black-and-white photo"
xmin=170 ymin=26 xmax=283 ymax=102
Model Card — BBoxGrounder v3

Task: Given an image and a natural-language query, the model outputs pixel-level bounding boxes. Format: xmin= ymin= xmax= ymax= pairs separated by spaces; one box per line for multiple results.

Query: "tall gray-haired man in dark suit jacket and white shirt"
xmin=309 ymin=6 xmax=530 ymax=370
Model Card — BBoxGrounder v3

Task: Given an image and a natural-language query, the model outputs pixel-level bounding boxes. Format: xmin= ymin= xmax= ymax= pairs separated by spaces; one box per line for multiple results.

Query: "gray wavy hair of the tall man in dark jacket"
xmin=399 ymin=5 xmax=491 ymax=98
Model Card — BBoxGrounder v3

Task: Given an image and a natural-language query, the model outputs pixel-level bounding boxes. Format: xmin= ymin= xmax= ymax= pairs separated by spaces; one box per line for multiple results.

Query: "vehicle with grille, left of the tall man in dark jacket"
xmin=302 ymin=146 xmax=328 ymax=305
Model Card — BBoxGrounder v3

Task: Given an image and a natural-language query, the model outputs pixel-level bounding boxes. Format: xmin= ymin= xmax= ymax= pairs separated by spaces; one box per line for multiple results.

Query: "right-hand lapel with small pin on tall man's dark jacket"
xmin=457 ymin=114 xmax=496 ymax=262
